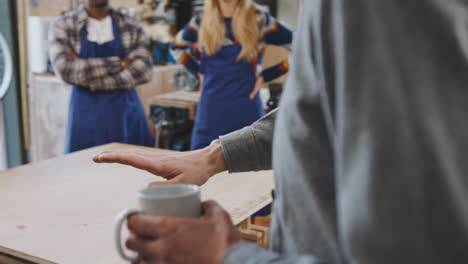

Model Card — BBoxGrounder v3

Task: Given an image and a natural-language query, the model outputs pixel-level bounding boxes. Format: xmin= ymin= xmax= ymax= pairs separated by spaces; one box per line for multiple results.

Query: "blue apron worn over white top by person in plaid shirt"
xmin=65 ymin=19 xmax=153 ymax=153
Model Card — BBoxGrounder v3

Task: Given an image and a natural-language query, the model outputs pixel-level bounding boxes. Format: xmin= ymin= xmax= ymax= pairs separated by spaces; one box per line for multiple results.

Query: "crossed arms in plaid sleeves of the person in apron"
xmin=49 ymin=19 xmax=152 ymax=90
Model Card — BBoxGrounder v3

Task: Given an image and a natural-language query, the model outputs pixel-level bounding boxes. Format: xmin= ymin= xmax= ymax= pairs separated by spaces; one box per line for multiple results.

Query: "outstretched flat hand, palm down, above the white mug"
xmin=93 ymin=140 xmax=226 ymax=185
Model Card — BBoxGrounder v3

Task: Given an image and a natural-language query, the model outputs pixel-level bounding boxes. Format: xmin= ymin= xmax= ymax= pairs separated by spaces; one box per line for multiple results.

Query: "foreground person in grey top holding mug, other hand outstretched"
xmin=95 ymin=0 xmax=468 ymax=264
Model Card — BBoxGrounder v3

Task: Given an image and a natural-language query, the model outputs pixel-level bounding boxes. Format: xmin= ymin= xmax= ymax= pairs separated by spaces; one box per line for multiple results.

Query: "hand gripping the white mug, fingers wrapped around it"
xmin=126 ymin=201 xmax=241 ymax=264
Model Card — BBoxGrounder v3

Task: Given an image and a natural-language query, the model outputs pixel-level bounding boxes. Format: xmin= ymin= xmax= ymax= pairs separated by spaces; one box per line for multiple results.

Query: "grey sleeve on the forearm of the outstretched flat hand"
xmin=220 ymin=111 xmax=276 ymax=173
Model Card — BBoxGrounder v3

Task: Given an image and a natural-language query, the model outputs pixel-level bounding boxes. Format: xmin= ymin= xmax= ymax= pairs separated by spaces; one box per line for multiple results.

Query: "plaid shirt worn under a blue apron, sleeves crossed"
xmin=49 ymin=6 xmax=153 ymax=91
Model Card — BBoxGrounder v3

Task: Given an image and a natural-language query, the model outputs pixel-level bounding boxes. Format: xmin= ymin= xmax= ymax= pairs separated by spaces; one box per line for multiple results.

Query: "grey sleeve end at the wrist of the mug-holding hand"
xmin=222 ymin=242 xmax=326 ymax=264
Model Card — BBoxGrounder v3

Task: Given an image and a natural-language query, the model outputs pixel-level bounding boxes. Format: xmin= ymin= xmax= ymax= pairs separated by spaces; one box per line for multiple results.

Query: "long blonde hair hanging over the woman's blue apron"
xmin=199 ymin=0 xmax=260 ymax=62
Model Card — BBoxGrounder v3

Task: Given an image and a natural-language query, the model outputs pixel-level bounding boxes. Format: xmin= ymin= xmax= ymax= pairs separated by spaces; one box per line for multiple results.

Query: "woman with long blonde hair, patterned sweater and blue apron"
xmin=171 ymin=0 xmax=292 ymax=150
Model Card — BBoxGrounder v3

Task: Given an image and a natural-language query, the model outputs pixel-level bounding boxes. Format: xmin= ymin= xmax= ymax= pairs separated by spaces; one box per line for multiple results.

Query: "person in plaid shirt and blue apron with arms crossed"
xmin=49 ymin=0 xmax=153 ymax=153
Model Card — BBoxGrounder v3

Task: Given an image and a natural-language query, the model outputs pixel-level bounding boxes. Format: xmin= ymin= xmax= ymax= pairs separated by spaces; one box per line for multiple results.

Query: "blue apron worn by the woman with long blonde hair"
xmin=191 ymin=44 xmax=265 ymax=150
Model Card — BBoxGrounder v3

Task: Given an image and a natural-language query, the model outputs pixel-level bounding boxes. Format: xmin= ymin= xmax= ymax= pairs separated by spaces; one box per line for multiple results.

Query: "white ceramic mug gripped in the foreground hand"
xmin=114 ymin=184 xmax=201 ymax=262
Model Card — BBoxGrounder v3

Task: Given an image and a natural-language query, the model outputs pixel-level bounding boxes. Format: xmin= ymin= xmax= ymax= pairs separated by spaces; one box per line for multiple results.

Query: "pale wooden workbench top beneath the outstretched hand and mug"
xmin=0 ymin=144 xmax=273 ymax=264
